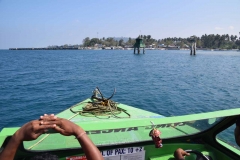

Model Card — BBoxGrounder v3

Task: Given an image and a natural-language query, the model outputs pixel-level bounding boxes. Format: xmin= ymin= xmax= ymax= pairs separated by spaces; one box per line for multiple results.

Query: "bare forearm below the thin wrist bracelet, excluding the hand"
xmin=78 ymin=134 xmax=103 ymax=160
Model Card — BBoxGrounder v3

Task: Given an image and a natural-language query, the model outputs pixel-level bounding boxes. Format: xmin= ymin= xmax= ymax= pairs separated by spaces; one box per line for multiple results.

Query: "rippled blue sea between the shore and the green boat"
xmin=0 ymin=50 xmax=240 ymax=130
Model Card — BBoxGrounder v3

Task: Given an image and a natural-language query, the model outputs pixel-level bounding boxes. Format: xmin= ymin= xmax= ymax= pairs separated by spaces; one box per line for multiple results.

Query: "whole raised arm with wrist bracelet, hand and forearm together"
xmin=40 ymin=115 xmax=103 ymax=160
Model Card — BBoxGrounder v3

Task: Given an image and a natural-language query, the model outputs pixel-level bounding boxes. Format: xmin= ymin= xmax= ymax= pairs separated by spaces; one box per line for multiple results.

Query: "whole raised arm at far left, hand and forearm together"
xmin=0 ymin=120 xmax=54 ymax=160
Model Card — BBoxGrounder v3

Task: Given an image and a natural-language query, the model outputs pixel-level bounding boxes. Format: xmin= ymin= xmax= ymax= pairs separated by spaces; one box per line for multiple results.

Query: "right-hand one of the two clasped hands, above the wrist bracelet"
xmin=40 ymin=114 xmax=85 ymax=136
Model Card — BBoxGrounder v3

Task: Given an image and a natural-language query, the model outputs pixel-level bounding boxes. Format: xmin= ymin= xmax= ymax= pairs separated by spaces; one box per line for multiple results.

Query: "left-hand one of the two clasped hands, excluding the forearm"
xmin=14 ymin=120 xmax=56 ymax=141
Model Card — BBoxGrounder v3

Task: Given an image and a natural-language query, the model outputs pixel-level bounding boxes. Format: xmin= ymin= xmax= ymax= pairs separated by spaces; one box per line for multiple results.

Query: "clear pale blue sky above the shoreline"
xmin=0 ymin=0 xmax=240 ymax=49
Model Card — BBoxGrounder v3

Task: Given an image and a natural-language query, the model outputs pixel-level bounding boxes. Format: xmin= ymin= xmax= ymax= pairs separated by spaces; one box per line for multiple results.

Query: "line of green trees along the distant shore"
xmin=82 ymin=34 xmax=240 ymax=49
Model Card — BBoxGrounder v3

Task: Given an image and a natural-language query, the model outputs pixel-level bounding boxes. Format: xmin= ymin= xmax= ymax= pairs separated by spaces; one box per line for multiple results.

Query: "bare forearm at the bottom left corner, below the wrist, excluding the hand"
xmin=0 ymin=134 xmax=21 ymax=160
